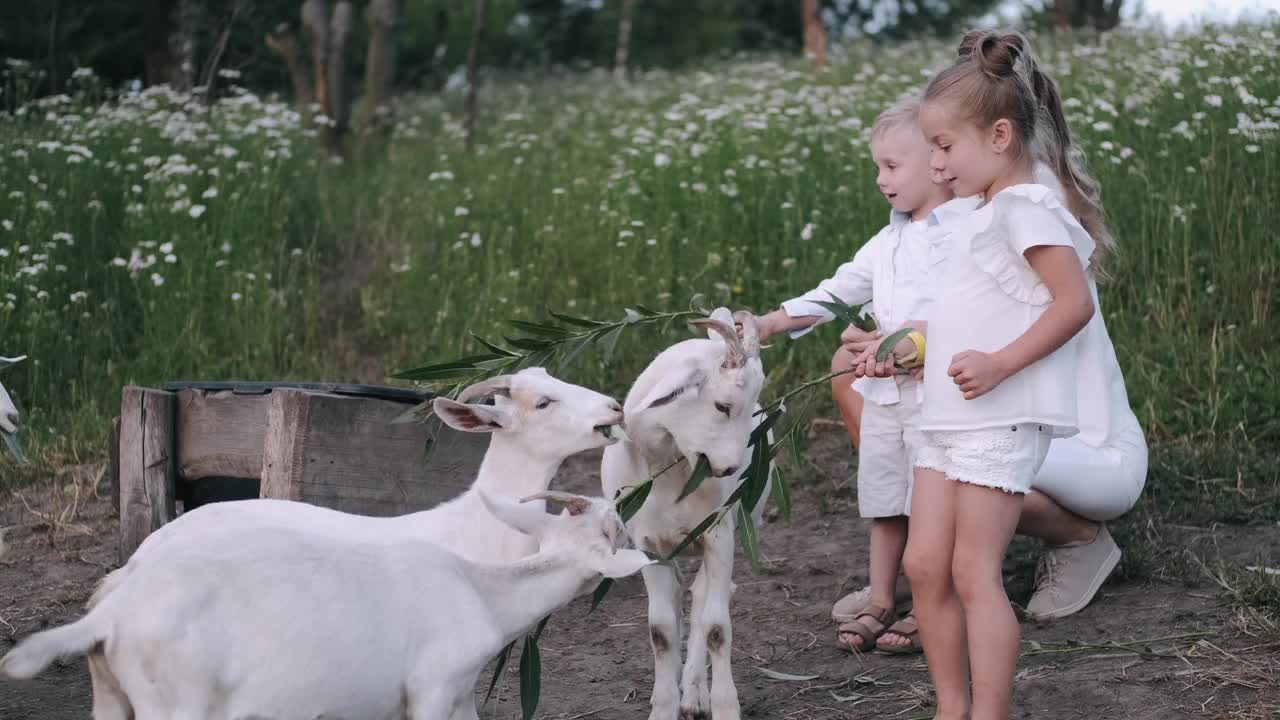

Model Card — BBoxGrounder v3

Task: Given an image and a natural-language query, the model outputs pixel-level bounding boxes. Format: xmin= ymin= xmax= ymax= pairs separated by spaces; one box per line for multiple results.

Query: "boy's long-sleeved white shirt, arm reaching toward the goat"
xmin=782 ymin=197 xmax=980 ymax=405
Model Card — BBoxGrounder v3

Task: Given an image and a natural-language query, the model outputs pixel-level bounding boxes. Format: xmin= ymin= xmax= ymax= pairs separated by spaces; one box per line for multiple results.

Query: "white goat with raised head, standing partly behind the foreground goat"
xmin=129 ymin=368 xmax=625 ymax=564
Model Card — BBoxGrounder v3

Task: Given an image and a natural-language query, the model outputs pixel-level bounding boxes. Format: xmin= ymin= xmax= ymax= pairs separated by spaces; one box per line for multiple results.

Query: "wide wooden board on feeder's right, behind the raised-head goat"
xmin=262 ymin=389 xmax=489 ymax=516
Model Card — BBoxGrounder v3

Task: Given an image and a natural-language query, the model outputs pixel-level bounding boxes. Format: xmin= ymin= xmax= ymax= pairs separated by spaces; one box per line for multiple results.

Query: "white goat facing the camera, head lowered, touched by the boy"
xmin=600 ymin=309 xmax=768 ymax=720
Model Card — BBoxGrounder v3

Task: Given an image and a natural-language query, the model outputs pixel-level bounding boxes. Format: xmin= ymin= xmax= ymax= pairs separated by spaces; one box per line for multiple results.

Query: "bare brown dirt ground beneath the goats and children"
xmin=0 ymin=427 xmax=1280 ymax=720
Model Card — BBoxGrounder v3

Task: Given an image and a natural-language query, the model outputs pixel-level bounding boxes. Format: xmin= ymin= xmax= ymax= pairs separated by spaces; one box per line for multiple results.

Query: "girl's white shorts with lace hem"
xmin=915 ymin=423 xmax=1052 ymax=495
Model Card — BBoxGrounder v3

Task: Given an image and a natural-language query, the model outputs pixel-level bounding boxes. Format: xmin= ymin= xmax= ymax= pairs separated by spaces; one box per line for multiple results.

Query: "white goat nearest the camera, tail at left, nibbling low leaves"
xmin=0 ymin=491 xmax=652 ymax=720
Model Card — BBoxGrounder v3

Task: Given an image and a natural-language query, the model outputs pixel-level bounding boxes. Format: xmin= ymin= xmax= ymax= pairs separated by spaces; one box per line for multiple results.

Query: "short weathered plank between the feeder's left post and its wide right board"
xmin=175 ymin=389 xmax=271 ymax=480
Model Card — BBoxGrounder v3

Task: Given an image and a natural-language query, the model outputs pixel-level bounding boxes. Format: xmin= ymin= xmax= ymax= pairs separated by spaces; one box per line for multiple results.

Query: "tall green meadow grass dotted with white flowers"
xmin=0 ymin=20 xmax=1280 ymax=538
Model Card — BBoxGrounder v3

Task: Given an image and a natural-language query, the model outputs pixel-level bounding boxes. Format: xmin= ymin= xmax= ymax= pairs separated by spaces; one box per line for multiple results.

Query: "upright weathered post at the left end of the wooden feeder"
xmin=120 ymin=386 xmax=177 ymax=565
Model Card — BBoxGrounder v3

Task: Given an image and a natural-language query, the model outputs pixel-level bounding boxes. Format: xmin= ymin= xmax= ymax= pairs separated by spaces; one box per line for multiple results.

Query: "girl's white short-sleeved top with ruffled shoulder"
xmin=922 ymin=183 xmax=1094 ymax=437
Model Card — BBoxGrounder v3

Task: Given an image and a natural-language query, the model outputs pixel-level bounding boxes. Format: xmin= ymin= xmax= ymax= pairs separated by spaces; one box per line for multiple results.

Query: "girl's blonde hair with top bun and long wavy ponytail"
xmin=924 ymin=31 xmax=1115 ymax=277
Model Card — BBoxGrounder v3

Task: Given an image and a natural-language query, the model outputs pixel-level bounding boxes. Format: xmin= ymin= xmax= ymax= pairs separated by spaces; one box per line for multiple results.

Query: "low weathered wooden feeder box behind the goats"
xmin=111 ymin=382 xmax=488 ymax=564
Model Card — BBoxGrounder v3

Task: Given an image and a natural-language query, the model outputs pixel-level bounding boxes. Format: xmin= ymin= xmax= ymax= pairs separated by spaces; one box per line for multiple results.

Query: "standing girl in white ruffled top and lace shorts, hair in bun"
xmin=905 ymin=32 xmax=1110 ymax=720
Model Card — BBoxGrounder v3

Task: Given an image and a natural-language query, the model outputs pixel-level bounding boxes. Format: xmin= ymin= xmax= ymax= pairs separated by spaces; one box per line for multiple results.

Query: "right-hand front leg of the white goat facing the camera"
xmin=690 ymin=514 xmax=741 ymax=720
